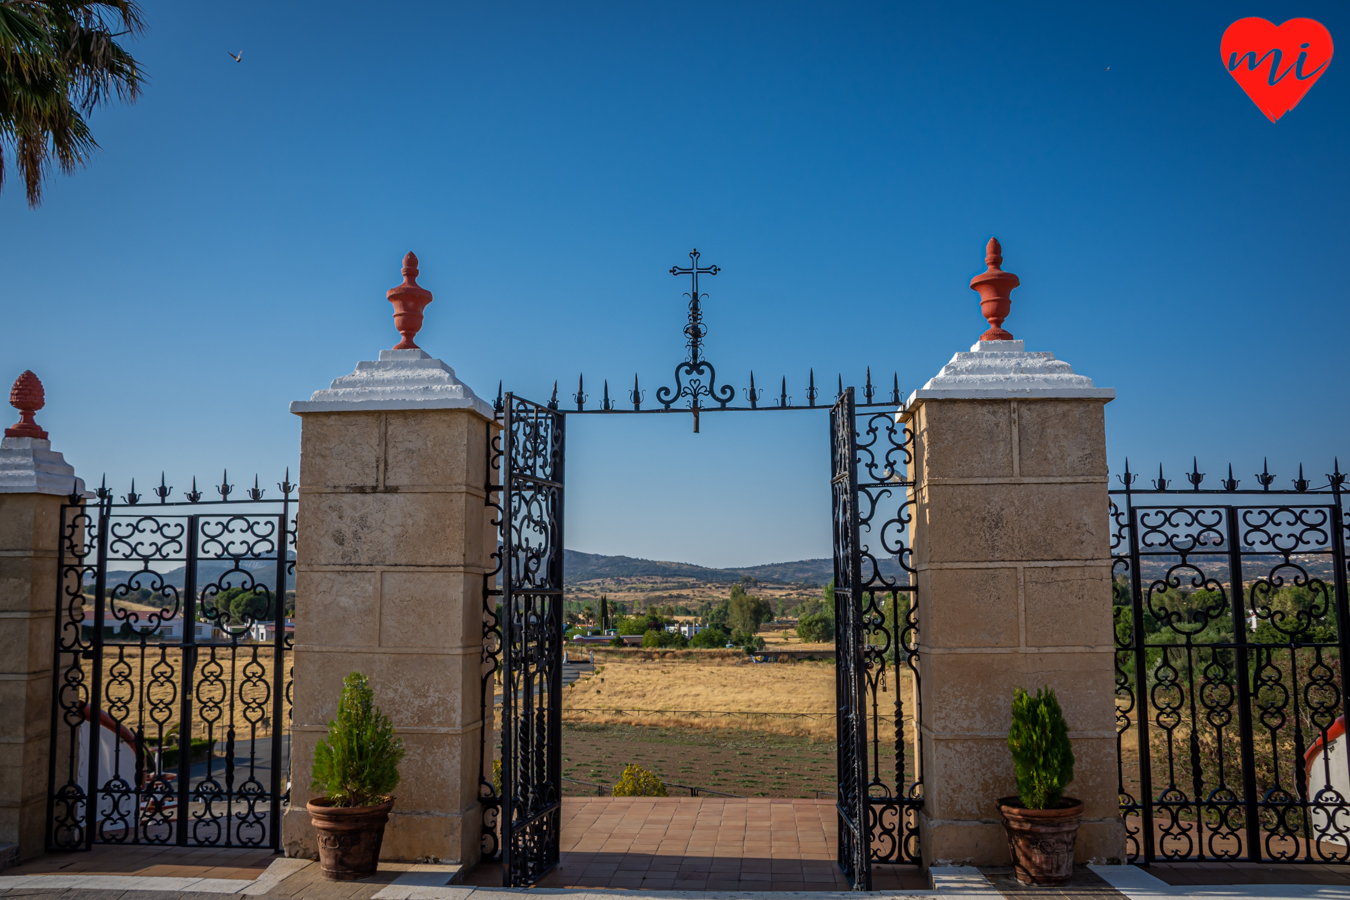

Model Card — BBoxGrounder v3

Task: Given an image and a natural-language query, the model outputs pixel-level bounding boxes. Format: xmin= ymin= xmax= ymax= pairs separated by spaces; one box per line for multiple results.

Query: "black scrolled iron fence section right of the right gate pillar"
xmin=1111 ymin=467 xmax=1350 ymax=862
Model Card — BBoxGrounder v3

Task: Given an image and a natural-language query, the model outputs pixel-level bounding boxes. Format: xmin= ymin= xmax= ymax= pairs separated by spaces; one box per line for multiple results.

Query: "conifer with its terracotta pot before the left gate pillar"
xmin=306 ymin=672 xmax=404 ymax=881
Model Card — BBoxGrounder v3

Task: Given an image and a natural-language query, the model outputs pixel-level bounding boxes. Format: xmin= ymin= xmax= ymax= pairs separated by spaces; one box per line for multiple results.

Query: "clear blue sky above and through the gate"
xmin=0 ymin=1 xmax=1350 ymax=565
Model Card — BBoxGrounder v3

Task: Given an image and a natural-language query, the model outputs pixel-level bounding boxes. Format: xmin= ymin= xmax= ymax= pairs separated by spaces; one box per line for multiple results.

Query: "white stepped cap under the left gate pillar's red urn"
xmin=290 ymin=349 xmax=494 ymax=420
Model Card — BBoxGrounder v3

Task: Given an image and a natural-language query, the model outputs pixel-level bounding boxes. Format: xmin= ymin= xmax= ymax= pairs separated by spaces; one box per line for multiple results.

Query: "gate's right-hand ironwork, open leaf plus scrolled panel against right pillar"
xmin=830 ymin=387 xmax=923 ymax=891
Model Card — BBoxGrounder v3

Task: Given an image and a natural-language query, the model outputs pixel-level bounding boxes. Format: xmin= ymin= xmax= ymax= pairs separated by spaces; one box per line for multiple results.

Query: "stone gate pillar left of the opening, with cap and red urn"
xmin=282 ymin=254 xmax=497 ymax=865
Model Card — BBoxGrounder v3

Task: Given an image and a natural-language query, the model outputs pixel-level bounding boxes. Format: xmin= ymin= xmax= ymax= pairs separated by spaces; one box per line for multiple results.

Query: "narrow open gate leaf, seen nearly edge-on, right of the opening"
xmin=830 ymin=387 xmax=872 ymax=891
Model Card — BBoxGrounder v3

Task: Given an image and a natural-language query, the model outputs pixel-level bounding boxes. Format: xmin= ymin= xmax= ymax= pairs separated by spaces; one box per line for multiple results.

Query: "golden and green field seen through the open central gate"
xmin=548 ymin=650 xmax=914 ymax=797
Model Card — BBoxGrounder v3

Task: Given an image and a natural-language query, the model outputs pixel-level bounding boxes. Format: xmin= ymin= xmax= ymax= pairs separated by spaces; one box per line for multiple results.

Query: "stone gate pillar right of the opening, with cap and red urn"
xmin=905 ymin=240 xmax=1125 ymax=865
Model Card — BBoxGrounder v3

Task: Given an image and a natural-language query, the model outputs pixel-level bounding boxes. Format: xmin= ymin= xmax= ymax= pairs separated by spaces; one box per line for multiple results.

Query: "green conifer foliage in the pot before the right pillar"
xmin=1008 ymin=687 xmax=1073 ymax=810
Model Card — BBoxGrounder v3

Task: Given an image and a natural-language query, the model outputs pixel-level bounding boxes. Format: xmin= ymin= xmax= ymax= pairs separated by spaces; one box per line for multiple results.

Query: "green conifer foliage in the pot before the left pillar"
xmin=311 ymin=672 xmax=404 ymax=807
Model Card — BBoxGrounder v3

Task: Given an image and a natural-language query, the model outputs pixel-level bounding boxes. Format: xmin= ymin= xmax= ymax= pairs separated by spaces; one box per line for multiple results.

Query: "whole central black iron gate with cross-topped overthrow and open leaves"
xmin=478 ymin=250 xmax=923 ymax=889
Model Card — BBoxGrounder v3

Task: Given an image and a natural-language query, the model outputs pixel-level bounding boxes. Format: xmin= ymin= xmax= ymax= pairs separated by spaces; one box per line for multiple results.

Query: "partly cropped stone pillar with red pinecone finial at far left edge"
xmin=0 ymin=372 xmax=84 ymax=869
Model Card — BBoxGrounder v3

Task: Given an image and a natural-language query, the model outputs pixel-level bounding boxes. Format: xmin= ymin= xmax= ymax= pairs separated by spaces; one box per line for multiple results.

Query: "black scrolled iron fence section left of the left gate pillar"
xmin=47 ymin=478 xmax=294 ymax=850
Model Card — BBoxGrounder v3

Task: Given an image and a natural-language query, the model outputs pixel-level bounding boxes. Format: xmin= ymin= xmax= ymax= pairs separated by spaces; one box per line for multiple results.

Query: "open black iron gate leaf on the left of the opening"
xmin=501 ymin=394 xmax=564 ymax=887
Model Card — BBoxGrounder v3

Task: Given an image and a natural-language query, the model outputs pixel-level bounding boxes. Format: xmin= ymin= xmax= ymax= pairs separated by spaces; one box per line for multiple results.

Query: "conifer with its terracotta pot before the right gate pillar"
xmin=999 ymin=688 xmax=1083 ymax=884
